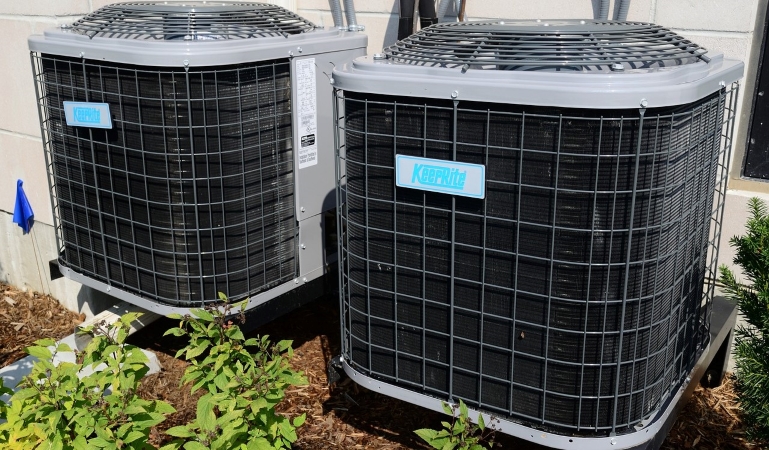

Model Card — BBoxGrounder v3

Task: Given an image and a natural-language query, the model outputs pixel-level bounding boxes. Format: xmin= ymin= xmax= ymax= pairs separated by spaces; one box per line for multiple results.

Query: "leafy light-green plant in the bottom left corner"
xmin=0 ymin=313 xmax=174 ymax=450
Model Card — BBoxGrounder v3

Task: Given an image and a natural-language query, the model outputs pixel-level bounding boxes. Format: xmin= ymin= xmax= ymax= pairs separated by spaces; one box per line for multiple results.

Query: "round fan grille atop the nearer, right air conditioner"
xmin=384 ymin=21 xmax=708 ymax=71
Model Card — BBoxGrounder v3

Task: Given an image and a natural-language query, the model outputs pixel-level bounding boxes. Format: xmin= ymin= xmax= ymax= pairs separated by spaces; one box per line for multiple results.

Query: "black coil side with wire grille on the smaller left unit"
xmin=32 ymin=54 xmax=297 ymax=306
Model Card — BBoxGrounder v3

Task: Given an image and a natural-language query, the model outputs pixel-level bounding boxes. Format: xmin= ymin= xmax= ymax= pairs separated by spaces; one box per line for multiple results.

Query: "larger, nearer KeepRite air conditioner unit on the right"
xmin=333 ymin=21 xmax=743 ymax=449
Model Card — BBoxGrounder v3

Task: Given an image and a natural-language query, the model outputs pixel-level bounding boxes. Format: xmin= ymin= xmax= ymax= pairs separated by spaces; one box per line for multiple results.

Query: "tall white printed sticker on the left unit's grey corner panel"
xmin=294 ymin=58 xmax=318 ymax=169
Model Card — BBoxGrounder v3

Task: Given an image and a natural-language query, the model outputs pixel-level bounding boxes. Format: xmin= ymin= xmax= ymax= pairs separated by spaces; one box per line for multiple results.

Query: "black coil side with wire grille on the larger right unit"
xmin=337 ymin=86 xmax=736 ymax=434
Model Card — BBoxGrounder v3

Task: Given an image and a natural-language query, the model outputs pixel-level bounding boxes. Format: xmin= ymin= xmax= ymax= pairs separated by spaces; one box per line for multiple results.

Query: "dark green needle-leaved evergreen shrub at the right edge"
xmin=720 ymin=198 xmax=769 ymax=442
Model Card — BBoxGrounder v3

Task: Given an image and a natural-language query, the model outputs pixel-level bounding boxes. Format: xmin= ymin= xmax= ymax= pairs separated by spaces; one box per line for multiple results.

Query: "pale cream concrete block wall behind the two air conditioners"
xmin=0 ymin=0 xmax=769 ymax=314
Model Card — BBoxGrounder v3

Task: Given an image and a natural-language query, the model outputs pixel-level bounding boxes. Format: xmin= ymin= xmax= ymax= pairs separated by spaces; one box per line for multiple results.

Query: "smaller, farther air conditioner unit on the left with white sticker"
xmin=29 ymin=1 xmax=367 ymax=313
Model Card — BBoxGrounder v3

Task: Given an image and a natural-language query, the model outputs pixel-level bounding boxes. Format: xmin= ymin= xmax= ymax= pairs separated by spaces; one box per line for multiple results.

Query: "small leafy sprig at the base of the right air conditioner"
xmin=414 ymin=400 xmax=494 ymax=450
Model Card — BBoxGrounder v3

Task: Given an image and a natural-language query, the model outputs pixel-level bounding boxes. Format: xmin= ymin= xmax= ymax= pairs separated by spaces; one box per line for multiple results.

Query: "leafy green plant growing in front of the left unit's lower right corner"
xmin=163 ymin=293 xmax=307 ymax=450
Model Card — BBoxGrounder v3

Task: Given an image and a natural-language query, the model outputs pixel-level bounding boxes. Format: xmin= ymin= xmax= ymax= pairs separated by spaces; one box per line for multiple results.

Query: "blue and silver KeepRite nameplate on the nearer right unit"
xmin=395 ymin=155 xmax=486 ymax=198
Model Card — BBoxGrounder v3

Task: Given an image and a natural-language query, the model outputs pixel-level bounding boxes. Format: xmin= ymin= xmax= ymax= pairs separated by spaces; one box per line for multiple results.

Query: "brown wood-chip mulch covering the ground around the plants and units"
xmin=0 ymin=283 xmax=760 ymax=450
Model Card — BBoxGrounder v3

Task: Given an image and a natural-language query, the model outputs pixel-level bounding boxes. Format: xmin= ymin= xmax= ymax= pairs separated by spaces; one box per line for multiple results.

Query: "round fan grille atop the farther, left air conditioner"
xmin=72 ymin=2 xmax=315 ymax=41
